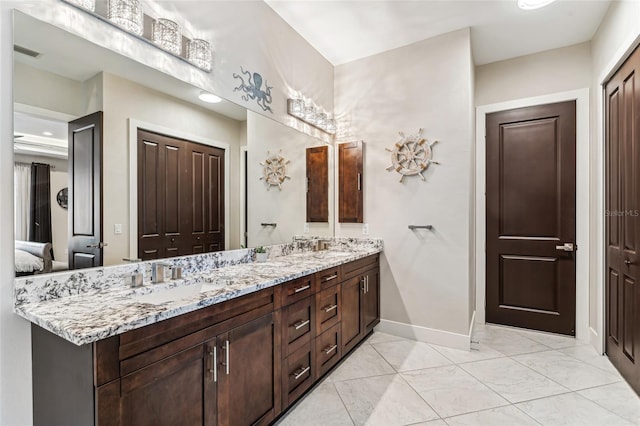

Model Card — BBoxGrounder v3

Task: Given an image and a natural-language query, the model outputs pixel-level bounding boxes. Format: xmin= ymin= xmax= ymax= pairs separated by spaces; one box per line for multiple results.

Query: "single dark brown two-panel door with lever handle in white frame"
xmin=486 ymin=101 xmax=576 ymax=335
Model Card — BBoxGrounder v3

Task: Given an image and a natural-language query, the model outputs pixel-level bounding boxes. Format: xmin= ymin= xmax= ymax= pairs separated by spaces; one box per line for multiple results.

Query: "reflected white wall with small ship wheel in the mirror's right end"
xmin=247 ymin=111 xmax=334 ymax=247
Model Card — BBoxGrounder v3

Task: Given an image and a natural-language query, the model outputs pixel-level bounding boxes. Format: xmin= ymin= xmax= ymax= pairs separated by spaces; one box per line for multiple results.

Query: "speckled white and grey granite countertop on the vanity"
xmin=14 ymin=247 xmax=381 ymax=345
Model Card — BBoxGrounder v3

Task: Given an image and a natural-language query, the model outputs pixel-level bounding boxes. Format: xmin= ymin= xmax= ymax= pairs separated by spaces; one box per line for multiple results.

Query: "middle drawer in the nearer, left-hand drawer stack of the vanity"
xmin=282 ymin=296 xmax=316 ymax=358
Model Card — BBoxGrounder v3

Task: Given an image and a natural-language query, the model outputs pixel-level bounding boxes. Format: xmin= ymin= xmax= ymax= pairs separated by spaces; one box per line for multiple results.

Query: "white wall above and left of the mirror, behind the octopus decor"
xmin=0 ymin=0 xmax=333 ymax=426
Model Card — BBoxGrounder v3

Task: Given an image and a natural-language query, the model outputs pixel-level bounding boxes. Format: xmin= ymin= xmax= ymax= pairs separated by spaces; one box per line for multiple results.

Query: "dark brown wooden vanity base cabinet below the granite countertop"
xmin=32 ymin=255 xmax=380 ymax=426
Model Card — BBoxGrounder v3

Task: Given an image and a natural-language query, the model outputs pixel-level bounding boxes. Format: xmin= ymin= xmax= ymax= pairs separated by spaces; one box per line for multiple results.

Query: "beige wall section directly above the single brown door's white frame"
xmin=475 ymin=42 xmax=592 ymax=106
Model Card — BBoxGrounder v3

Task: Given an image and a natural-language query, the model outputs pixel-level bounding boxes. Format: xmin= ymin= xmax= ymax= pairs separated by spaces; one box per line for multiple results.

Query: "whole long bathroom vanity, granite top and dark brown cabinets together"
xmin=16 ymin=243 xmax=381 ymax=426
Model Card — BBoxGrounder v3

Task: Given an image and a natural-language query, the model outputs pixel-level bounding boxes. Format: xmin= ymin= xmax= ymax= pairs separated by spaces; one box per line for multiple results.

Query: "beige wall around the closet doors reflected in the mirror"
xmin=103 ymin=73 xmax=240 ymax=265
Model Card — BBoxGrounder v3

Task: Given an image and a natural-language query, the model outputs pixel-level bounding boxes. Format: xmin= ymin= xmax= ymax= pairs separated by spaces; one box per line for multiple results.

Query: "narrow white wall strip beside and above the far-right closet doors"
xmin=589 ymin=1 xmax=640 ymax=350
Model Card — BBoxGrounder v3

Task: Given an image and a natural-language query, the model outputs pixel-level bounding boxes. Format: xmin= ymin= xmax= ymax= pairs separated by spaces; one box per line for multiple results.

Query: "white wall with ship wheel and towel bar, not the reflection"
xmin=334 ymin=29 xmax=473 ymax=347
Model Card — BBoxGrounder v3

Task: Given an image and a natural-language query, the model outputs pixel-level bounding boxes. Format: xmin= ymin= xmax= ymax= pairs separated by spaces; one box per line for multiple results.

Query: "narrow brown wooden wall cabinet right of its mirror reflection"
xmin=338 ymin=142 xmax=364 ymax=223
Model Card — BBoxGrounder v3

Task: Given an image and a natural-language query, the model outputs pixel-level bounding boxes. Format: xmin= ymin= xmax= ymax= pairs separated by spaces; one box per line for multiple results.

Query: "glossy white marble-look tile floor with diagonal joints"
xmin=278 ymin=325 xmax=640 ymax=426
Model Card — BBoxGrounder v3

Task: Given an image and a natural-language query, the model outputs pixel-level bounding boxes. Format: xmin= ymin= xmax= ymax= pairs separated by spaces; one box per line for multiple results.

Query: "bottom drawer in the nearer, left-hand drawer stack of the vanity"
xmin=282 ymin=340 xmax=316 ymax=406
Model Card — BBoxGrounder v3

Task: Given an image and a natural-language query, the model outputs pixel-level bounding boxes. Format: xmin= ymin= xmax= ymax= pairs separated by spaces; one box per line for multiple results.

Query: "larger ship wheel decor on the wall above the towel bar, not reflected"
xmin=387 ymin=129 xmax=440 ymax=183
